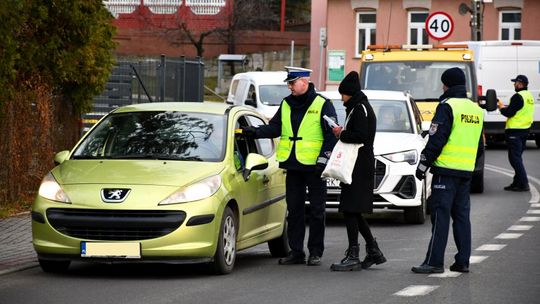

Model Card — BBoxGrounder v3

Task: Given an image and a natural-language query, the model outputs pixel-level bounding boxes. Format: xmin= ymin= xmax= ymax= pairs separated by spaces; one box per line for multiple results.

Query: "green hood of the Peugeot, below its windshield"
xmin=52 ymin=160 xmax=223 ymax=187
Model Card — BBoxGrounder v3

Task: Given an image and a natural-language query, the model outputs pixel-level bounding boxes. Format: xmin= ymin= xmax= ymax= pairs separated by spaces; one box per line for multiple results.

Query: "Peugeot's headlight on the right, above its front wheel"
xmin=159 ymin=175 xmax=221 ymax=205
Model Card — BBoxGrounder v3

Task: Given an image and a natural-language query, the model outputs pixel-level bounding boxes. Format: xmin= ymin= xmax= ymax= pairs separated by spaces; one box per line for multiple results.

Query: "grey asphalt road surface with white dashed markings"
xmin=0 ymin=142 xmax=540 ymax=304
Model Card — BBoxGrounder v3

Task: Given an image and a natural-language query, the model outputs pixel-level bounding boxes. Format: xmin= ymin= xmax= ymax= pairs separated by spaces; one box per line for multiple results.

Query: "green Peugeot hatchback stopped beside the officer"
xmin=32 ymin=102 xmax=288 ymax=274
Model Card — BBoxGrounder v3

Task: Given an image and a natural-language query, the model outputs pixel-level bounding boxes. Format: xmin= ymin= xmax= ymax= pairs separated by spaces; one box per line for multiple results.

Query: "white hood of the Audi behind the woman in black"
xmin=373 ymin=132 xmax=426 ymax=155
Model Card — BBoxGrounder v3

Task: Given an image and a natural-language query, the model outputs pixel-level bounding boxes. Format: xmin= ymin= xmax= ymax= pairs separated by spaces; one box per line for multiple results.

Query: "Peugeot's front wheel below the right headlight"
xmin=213 ymin=207 xmax=237 ymax=274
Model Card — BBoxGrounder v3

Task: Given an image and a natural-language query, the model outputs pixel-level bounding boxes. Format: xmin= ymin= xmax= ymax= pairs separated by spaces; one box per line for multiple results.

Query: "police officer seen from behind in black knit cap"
xmin=411 ymin=68 xmax=484 ymax=273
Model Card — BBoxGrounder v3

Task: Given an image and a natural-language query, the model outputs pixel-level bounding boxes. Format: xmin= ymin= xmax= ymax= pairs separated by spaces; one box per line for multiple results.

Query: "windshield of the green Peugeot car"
xmin=72 ymin=112 xmax=225 ymax=162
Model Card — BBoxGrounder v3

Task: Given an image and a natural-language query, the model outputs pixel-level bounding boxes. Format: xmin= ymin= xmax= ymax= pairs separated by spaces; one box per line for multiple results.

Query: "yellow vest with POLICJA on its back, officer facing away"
xmin=433 ymin=98 xmax=484 ymax=172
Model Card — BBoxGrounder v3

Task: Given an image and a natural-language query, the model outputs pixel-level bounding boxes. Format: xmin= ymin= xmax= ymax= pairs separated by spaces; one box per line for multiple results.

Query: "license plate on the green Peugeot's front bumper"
xmin=81 ymin=242 xmax=141 ymax=259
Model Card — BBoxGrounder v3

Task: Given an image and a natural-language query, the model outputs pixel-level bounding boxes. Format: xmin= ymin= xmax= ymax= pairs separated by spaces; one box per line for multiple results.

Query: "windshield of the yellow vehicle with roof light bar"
xmin=362 ymin=61 xmax=473 ymax=101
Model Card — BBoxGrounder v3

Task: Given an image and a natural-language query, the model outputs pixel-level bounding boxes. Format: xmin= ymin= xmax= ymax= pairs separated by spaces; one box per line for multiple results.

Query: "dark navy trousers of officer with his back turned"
xmin=424 ymin=174 xmax=471 ymax=267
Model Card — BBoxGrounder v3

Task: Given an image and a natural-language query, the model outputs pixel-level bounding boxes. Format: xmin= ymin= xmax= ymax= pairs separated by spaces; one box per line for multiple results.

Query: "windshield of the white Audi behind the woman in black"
xmin=333 ymin=99 xmax=414 ymax=133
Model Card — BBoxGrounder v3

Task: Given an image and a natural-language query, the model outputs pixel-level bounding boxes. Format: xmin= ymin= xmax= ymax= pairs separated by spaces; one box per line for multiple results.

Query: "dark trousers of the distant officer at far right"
xmin=505 ymin=132 xmax=529 ymax=188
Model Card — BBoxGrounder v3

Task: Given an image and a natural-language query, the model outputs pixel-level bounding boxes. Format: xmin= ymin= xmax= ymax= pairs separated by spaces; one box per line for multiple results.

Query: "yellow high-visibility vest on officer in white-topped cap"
xmin=276 ymin=96 xmax=325 ymax=165
